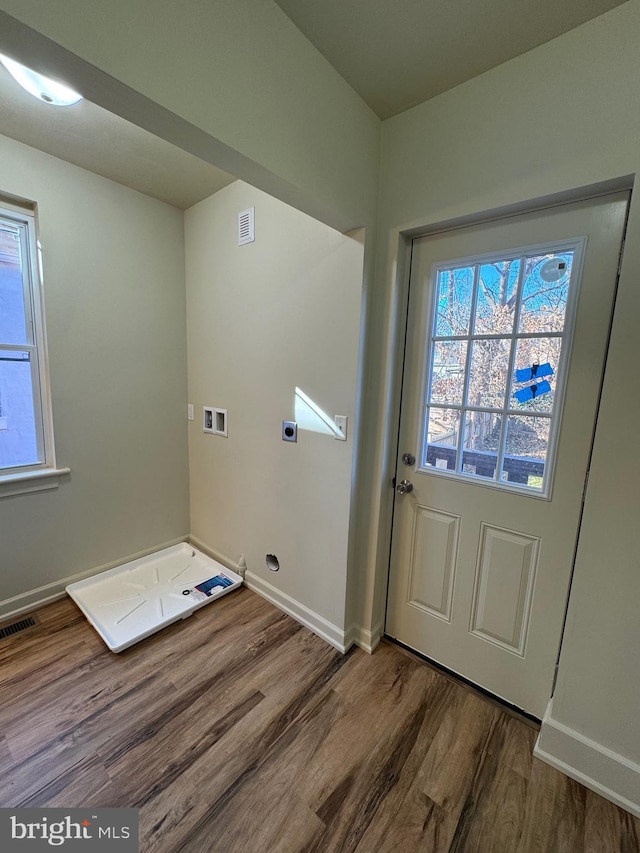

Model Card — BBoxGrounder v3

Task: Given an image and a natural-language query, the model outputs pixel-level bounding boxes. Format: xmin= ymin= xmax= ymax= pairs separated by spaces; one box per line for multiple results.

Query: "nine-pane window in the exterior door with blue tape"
xmin=421 ymin=238 xmax=584 ymax=497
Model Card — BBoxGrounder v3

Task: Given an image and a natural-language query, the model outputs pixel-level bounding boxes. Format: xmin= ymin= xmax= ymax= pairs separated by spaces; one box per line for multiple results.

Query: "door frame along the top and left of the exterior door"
xmin=366 ymin=175 xmax=634 ymax=650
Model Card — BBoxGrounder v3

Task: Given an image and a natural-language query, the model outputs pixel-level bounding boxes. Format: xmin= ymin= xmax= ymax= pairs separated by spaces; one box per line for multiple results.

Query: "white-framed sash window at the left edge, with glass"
xmin=0 ymin=201 xmax=62 ymax=495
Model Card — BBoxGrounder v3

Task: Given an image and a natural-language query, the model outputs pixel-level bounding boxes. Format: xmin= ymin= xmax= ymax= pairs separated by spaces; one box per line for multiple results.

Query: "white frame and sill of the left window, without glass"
xmin=0 ymin=196 xmax=69 ymax=497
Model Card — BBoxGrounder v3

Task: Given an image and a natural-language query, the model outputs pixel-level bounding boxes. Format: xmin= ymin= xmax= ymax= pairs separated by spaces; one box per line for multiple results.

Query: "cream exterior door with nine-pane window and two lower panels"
xmin=386 ymin=193 xmax=628 ymax=718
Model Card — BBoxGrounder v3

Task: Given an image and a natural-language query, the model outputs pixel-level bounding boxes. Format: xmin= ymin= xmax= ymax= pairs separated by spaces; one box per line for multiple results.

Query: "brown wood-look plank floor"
xmin=0 ymin=589 xmax=640 ymax=853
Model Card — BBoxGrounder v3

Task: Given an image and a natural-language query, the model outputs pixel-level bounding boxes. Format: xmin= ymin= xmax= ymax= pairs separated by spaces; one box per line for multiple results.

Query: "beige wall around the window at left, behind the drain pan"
xmin=0 ymin=137 xmax=189 ymax=613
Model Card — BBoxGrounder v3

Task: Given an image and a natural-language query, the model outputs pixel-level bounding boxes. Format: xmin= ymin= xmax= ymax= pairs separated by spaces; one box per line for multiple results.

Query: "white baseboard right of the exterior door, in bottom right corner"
xmin=533 ymin=699 xmax=640 ymax=818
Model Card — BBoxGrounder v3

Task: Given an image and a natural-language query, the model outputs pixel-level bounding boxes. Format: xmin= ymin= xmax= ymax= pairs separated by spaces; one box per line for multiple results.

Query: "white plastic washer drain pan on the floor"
xmin=67 ymin=542 xmax=242 ymax=652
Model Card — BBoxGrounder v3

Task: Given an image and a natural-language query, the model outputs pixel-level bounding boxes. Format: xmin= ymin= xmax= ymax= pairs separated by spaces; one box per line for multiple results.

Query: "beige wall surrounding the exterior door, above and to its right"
xmin=362 ymin=0 xmax=640 ymax=807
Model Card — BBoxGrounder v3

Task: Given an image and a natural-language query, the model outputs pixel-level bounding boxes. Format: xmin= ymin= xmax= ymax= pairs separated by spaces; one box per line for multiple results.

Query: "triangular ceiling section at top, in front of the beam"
xmin=275 ymin=0 xmax=626 ymax=119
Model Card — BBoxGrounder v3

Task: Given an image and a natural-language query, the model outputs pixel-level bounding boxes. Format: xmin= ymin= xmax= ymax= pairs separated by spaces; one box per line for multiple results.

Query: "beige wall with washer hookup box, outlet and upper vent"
xmin=185 ymin=181 xmax=363 ymax=629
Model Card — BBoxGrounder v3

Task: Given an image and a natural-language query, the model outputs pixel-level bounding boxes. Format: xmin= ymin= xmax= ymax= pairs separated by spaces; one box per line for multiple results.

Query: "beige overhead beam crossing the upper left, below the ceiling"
xmin=0 ymin=0 xmax=380 ymax=230
